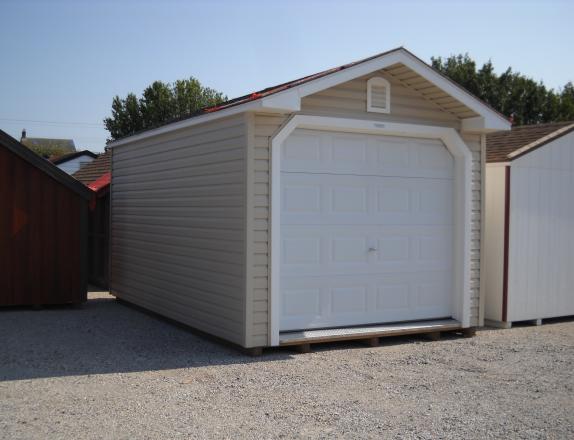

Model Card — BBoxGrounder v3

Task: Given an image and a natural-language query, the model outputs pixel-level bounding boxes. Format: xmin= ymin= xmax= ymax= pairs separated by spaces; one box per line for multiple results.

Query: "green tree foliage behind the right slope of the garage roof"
xmin=431 ymin=54 xmax=574 ymax=125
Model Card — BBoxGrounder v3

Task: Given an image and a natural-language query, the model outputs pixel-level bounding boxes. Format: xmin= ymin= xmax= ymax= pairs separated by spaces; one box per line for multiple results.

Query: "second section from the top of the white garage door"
xmin=281 ymin=173 xmax=453 ymax=225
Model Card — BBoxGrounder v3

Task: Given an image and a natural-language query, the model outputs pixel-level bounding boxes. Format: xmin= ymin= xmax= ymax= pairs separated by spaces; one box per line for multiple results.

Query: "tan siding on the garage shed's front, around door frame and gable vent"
xmin=247 ymin=74 xmax=481 ymax=346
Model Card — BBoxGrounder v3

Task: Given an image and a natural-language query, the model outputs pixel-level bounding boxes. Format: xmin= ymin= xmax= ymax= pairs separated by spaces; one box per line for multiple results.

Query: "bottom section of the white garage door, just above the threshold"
xmin=281 ymin=272 xmax=452 ymax=330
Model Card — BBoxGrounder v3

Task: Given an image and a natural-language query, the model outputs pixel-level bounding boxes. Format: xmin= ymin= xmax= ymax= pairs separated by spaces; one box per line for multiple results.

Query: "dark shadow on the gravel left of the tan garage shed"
xmin=0 ymin=295 xmax=290 ymax=381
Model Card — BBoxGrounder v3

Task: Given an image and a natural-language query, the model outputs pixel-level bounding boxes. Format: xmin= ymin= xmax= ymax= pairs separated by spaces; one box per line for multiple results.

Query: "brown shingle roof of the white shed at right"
xmin=486 ymin=121 xmax=574 ymax=162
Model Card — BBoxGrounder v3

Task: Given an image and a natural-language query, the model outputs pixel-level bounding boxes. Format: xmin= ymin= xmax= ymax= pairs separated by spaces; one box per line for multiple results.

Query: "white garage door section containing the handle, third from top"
xmin=281 ymin=225 xmax=453 ymax=276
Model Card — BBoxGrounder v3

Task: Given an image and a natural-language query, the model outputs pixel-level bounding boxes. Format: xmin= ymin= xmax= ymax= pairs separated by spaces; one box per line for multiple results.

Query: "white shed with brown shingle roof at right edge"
xmin=485 ymin=122 xmax=574 ymax=327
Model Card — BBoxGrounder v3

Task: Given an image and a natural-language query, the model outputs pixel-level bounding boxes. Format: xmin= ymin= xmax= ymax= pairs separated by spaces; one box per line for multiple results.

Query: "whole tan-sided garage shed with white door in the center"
xmin=110 ymin=48 xmax=510 ymax=348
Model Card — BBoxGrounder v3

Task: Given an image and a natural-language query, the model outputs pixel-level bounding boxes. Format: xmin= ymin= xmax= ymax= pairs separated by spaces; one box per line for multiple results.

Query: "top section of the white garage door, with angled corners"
xmin=281 ymin=130 xmax=454 ymax=178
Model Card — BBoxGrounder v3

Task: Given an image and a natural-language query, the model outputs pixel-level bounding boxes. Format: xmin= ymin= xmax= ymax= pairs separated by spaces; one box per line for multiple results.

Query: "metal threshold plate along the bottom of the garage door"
xmin=279 ymin=319 xmax=462 ymax=345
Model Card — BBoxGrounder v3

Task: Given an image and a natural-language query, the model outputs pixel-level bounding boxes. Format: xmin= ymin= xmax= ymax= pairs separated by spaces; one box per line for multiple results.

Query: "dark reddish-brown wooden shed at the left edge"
xmin=0 ymin=131 xmax=91 ymax=306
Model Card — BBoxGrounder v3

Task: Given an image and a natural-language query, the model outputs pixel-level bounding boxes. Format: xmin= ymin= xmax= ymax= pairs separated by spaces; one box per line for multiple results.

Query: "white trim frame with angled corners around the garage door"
xmin=269 ymin=115 xmax=472 ymax=346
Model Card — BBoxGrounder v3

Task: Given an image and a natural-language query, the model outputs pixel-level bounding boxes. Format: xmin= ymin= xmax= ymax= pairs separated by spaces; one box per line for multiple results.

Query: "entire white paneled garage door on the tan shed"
xmin=280 ymin=130 xmax=454 ymax=331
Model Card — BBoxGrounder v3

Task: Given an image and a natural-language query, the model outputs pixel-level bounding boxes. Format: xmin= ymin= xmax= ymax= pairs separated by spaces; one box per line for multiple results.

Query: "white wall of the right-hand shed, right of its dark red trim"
xmin=508 ymin=133 xmax=574 ymax=321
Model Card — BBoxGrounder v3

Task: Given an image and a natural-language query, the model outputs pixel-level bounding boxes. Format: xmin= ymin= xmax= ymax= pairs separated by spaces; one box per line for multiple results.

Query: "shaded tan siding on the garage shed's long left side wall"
xmin=111 ymin=115 xmax=247 ymax=345
